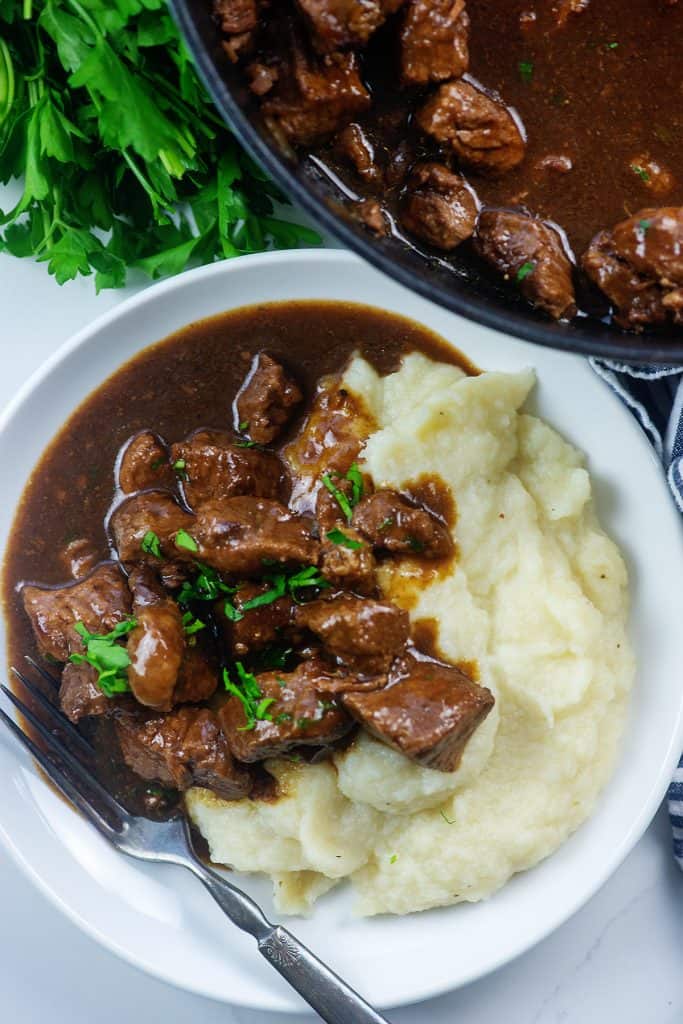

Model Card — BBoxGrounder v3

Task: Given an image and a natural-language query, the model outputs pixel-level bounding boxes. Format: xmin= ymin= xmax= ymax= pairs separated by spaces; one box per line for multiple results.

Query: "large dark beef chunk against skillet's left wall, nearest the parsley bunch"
xmin=261 ymin=23 xmax=370 ymax=145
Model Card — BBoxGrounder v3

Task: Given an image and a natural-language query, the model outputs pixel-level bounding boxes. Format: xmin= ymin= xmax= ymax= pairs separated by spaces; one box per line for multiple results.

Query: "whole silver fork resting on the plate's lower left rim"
xmin=0 ymin=657 xmax=388 ymax=1024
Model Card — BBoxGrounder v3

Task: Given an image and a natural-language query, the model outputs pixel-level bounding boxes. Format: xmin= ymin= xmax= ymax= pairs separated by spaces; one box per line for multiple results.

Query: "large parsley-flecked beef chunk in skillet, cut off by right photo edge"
xmin=582 ymin=207 xmax=683 ymax=331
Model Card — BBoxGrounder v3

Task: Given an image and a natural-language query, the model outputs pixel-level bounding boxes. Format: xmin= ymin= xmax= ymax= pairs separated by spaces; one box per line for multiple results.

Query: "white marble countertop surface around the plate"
xmin=0 ymin=249 xmax=683 ymax=1024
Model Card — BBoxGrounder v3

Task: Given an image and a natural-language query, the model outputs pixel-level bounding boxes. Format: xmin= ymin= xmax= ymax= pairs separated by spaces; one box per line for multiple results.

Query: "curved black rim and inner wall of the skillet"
xmin=169 ymin=0 xmax=683 ymax=366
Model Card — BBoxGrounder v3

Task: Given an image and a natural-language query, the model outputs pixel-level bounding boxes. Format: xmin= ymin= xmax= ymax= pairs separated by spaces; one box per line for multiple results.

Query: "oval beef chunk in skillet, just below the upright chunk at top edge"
xmin=417 ymin=81 xmax=525 ymax=174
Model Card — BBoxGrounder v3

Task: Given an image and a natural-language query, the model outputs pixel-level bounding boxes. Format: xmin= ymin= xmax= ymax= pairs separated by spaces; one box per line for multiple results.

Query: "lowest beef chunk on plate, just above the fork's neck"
xmin=116 ymin=708 xmax=251 ymax=800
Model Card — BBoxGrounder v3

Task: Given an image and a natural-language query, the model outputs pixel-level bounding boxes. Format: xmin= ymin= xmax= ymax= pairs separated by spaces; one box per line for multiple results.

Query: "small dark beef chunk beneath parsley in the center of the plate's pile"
xmin=214 ymin=583 xmax=293 ymax=658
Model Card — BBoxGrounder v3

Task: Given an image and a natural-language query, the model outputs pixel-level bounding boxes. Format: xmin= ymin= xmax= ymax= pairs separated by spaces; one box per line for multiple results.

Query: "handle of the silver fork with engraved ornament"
xmin=183 ymin=853 xmax=389 ymax=1024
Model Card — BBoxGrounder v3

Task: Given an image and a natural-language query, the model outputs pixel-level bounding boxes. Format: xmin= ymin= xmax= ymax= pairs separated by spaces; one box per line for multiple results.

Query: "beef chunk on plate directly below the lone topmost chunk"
xmin=171 ymin=430 xmax=283 ymax=508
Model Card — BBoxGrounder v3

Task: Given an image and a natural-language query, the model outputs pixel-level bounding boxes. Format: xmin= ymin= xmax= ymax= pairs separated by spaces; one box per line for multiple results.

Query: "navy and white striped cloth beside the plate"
xmin=590 ymin=358 xmax=683 ymax=870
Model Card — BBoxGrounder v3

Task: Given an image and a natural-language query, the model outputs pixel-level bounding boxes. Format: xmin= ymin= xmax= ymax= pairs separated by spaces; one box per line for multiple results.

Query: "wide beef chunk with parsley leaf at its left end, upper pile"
xmin=183 ymin=498 xmax=319 ymax=577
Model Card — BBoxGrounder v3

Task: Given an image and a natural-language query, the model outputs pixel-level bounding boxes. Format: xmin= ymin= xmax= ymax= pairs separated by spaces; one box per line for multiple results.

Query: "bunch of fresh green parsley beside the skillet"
xmin=0 ymin=0 xmax=319 ymax=290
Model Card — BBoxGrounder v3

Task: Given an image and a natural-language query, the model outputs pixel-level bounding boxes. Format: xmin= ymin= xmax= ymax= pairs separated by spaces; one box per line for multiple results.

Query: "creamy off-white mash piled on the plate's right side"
xmin=187 ymin=353 xmax=634 ymax=914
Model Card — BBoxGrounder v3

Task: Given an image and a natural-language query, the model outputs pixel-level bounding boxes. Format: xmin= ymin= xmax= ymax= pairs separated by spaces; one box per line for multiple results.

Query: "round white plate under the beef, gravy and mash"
xmin=0 ymin=251 xmax=683 ymax=1011
